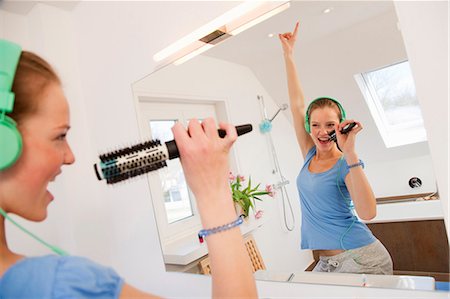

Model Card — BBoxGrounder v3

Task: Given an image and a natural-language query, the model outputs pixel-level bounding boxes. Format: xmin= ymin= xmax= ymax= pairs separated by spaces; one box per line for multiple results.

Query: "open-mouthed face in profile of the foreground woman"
xmin=0 ymin=83 xmax=75 ymax=221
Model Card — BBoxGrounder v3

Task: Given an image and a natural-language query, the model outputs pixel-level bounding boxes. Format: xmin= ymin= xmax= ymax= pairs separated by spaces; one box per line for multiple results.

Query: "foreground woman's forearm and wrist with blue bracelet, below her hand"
xmin=199 ymin=194 xmax=257 ymax=298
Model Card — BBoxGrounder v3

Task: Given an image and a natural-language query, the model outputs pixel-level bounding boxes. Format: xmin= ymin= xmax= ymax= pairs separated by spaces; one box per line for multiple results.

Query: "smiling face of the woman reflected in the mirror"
xmin=310 ymin=106 xmax=339 ymax=151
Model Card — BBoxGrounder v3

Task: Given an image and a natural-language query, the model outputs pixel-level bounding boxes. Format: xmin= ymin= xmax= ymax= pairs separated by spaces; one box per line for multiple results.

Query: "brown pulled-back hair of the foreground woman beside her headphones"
xmin=8 ymin=51 xmax=61 ymax=125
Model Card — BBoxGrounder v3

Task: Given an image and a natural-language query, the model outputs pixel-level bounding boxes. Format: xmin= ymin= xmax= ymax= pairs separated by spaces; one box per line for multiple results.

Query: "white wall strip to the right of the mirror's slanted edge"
xmin=395 ymin=1 xmax=450 ymax=240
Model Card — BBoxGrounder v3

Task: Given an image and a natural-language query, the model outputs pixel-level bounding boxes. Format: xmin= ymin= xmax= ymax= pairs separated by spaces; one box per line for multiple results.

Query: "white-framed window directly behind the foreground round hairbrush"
xmin=138 ymin=96 xmax=217 ymax=247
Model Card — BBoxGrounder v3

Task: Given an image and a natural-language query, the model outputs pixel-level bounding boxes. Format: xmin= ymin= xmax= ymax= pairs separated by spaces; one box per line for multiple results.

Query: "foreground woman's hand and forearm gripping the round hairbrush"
xmin=172 ymin=118 xmax=257 ymax=298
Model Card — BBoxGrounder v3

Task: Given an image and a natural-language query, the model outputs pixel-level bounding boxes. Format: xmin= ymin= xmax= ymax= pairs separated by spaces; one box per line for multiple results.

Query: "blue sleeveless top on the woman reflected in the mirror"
xmin=297 ymin=146 xmax=376 ymax=250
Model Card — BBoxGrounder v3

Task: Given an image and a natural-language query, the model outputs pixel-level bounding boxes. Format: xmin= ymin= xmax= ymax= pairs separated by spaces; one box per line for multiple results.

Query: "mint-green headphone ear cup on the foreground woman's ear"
xmin=0 ymin=116 xmax=22 ymax=170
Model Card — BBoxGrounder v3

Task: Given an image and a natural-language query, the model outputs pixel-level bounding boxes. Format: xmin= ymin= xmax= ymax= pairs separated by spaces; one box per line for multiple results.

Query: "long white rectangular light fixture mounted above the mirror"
xmin=153 ymin=0 xmax=290 ymax=65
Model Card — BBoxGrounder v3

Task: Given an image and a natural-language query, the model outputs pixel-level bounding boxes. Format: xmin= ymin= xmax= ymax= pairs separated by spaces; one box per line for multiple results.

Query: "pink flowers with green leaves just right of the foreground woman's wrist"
xmin=229 ymin=172 xmax=275 ymax=219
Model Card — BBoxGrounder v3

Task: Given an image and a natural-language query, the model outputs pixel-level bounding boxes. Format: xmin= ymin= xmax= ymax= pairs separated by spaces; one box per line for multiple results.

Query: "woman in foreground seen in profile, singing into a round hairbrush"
xmin=0 ymin=40 xmax=257 ymax=299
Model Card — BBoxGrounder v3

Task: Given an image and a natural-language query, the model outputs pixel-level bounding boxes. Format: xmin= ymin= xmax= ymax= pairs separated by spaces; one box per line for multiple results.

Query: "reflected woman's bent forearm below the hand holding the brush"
xmin=346 ymin=154 xmax=377 ymax=220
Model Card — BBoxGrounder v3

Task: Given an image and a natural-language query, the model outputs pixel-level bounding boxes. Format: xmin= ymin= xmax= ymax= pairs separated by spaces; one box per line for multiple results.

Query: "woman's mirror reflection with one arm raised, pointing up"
xmin=279 ymin=23 xmax=393 ymax=274
